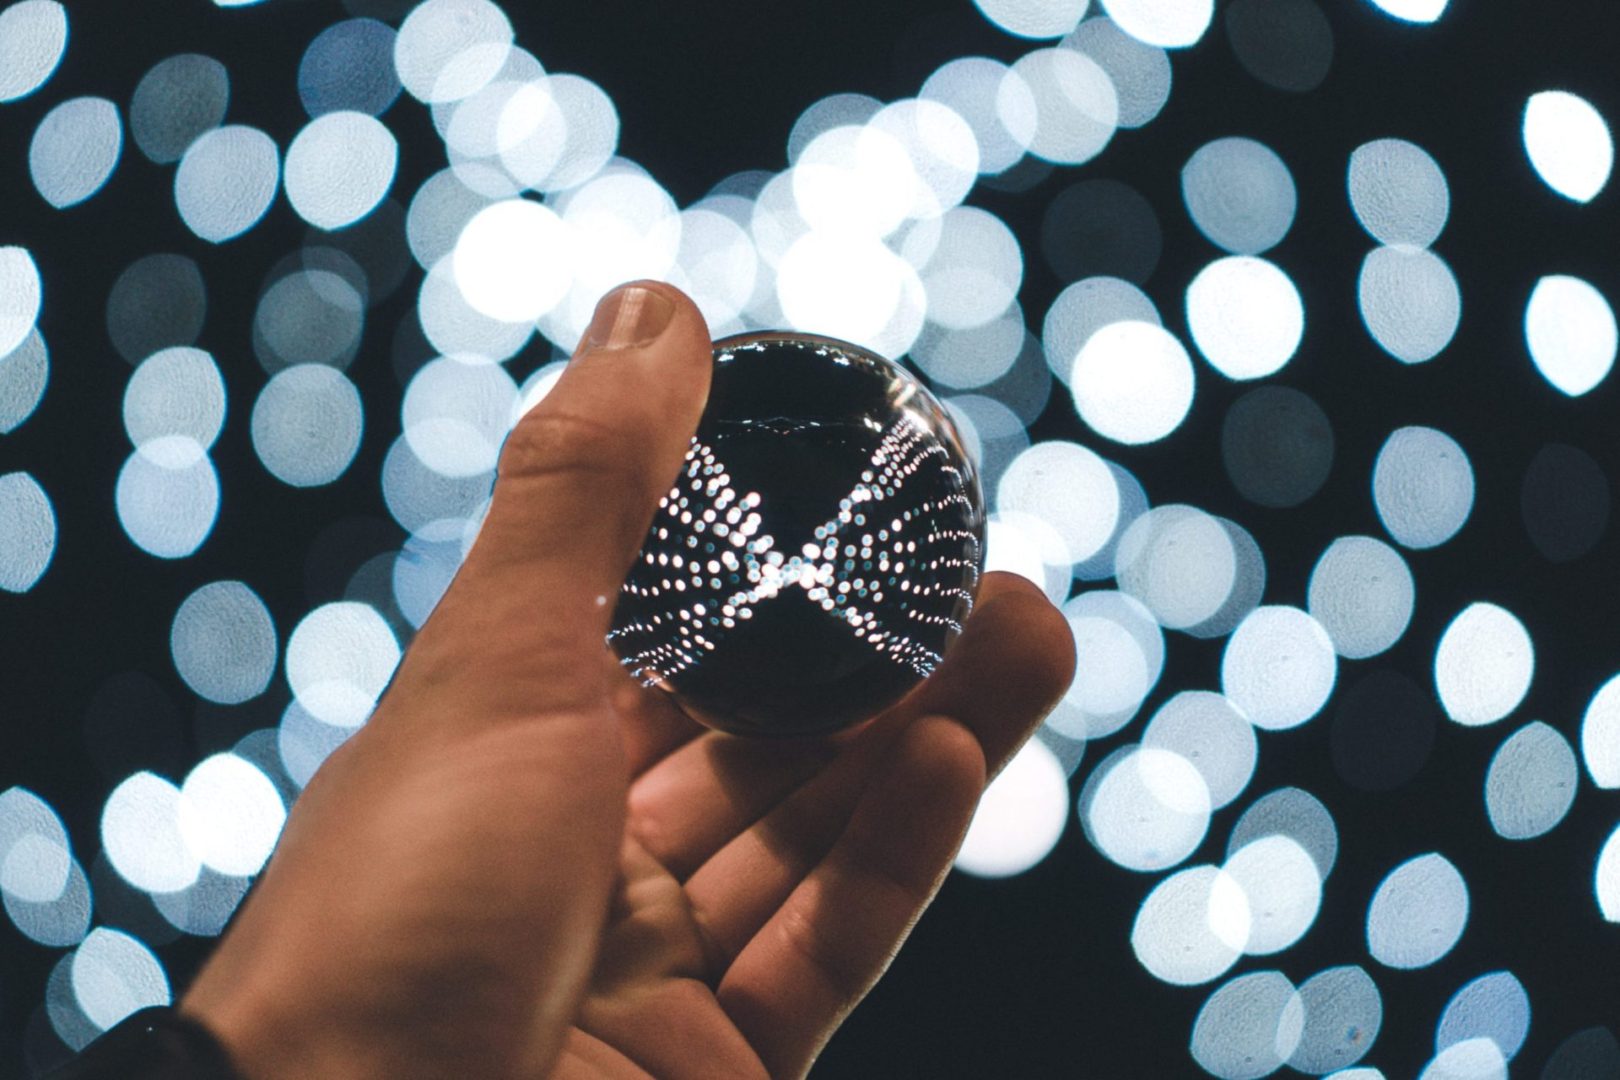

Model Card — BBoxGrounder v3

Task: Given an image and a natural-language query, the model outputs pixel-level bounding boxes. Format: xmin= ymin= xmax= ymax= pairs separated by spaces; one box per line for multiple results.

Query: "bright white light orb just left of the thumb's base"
xmin=287 ymin=601 xmax=400 ymax=727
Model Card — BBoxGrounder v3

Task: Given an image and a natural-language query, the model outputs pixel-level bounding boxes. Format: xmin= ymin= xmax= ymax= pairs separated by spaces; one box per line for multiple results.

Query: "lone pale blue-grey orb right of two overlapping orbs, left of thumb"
xmin=249 ymin=364 xmax=365 ymax=487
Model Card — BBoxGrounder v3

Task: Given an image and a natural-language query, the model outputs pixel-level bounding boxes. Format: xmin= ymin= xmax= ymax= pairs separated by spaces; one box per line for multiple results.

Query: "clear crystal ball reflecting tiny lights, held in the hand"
xmin=608 ymin=332 xmax=985 ymax=735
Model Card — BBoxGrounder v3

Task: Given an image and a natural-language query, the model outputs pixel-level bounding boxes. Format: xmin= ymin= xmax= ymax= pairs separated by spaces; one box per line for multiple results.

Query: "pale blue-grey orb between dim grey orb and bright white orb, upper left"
xmin=175 ymin=125 xmax=282 ymax=244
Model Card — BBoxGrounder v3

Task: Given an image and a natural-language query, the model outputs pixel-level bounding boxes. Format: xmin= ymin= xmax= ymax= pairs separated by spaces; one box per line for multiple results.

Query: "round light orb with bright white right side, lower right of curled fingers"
xmin=1079 ymin=746 xmax=1210 ymax=873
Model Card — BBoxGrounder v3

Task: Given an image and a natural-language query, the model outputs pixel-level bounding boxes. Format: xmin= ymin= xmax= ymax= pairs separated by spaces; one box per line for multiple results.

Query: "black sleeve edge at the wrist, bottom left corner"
xmin=45 ymin=1007 xmax=243 ymax=1080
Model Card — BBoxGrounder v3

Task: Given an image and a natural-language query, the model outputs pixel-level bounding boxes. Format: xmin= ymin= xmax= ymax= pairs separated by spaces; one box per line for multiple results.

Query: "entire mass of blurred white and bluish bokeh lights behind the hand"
xmin=0 ymin=0 xmax=1620 ymax=1080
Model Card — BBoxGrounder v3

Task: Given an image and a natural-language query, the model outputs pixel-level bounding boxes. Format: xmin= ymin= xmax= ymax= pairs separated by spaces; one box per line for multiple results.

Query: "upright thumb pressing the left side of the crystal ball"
xmin=402 ymin=282 xmax=713 ymax=719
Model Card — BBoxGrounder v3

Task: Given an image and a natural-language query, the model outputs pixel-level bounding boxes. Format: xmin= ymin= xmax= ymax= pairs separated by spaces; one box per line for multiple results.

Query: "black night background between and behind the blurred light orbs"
xmin=0 ymin=0 xmax=1620 ymax=1080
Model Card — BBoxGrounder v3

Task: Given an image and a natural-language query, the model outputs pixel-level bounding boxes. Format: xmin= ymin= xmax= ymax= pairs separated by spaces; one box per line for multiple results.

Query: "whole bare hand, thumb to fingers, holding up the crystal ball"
xmin=181 ymin=282 xmax=1074 ymax=1080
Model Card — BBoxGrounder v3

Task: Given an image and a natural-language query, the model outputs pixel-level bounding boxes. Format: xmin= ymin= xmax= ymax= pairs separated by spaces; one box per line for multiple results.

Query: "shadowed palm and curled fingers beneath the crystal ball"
xmin=557 ymin=575 xmax=1068 ymax=1080
